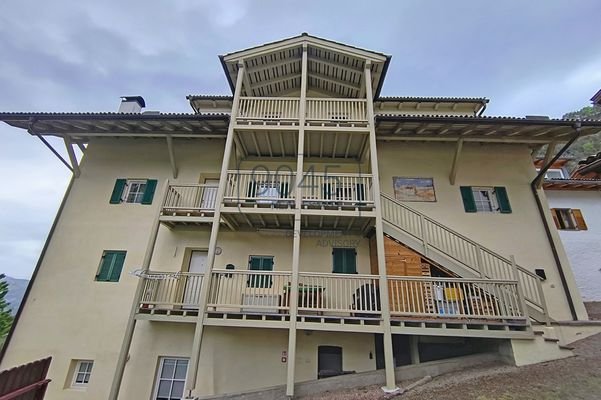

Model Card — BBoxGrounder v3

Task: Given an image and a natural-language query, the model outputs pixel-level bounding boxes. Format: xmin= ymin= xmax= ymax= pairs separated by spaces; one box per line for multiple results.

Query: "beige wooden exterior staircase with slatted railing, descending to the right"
xmin=381 ymin=193 xmax=550 ymax=324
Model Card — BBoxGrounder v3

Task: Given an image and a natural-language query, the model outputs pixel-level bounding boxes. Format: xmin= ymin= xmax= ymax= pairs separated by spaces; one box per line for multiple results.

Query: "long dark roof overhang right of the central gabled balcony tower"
xmin=376 ymin=115 xmax=601 ymax=146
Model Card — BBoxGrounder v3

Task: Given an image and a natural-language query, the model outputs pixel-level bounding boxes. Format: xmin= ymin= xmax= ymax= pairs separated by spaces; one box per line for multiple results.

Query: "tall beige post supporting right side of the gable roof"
xmin=365 ymin=61 xmax=398 ymax=392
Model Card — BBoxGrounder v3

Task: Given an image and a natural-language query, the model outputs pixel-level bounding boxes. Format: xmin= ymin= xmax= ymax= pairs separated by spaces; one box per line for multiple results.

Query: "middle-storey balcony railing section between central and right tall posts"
xmin=299 ymin=173 xmax=374 ymax=207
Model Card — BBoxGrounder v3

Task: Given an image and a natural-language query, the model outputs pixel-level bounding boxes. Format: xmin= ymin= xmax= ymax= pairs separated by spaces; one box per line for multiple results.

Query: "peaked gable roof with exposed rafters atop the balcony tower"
xmin=219 ymin=33 xmax=391 ymax=98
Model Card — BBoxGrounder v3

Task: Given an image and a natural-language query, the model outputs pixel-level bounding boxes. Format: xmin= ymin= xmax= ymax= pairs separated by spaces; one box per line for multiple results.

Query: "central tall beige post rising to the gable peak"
xmin=286 ymin=44 xmax=307 ymax=397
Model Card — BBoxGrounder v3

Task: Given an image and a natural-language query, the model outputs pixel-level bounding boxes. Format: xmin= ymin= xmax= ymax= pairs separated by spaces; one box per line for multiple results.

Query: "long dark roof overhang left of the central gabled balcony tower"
xmin=0 ymin=113 xmax=229 ymax=143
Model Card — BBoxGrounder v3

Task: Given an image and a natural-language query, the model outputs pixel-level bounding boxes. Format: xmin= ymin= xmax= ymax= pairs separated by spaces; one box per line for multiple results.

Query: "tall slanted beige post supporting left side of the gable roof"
xmin=186 ymin=61 xmax=244 ymax=395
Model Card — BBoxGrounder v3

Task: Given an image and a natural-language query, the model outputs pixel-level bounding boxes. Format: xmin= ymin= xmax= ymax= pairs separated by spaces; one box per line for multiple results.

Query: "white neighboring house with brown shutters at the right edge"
xmin=538 ymin=153 xmax=601 ymax=301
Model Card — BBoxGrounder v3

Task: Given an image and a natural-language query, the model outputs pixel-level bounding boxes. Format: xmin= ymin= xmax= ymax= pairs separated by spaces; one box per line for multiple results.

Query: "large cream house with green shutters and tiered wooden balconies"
xmin=0 ymin=34 xmax=601 ymax=399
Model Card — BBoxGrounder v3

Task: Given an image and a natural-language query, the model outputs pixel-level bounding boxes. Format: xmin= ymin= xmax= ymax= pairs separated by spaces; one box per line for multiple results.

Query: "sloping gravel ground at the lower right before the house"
xmin=305 ymin=334 xmax=601 ymax=400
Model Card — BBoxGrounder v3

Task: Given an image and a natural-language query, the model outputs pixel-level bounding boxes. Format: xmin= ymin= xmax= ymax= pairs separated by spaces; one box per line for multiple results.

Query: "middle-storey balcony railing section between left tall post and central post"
xmin=223 ymin=171 xmax=294 ymax=205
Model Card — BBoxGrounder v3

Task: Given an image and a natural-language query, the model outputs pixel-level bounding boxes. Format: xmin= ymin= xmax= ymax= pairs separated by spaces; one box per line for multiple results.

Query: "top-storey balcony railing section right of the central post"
xmin=306 ymin=98 xmax=367 ymax=122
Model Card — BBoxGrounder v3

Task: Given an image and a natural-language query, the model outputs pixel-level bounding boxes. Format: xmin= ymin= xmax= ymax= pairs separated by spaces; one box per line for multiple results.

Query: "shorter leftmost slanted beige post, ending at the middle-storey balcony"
xmin=108 ymin=180 xmax=169 ymax=400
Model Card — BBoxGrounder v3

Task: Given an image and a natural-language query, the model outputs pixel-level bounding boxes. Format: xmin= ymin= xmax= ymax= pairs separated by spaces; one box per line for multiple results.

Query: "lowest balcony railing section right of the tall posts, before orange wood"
xmin=388 ymin=276 xmax=526 ymax=320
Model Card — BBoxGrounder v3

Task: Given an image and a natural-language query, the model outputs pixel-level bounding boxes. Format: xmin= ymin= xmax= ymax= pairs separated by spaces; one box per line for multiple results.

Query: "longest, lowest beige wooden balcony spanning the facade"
xmin=138 ymin=269 xmax=529 ymax=337
